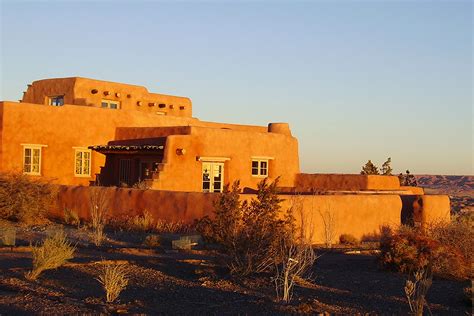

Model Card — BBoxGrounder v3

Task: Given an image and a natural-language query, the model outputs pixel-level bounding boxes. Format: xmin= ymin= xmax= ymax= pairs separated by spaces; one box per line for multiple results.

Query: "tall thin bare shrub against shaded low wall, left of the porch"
xmin=89 ymin=187 xmax=108 ymax=246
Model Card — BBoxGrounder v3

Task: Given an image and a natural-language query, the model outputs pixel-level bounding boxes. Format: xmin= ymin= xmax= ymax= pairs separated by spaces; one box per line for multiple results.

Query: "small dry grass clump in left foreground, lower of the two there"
xmin=97 ymin=264 xmax=128 ymax=303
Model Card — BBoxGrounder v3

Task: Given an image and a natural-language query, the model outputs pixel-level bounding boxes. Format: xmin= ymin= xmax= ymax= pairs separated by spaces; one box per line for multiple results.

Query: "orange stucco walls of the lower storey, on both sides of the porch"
xmin=0 ymin=102 xmax=299 ymax=191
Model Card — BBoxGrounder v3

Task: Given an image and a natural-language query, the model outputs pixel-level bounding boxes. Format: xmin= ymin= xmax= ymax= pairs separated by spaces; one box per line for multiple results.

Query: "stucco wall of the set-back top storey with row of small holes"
xmin=22 ymin=77 xmax=192 ymax=117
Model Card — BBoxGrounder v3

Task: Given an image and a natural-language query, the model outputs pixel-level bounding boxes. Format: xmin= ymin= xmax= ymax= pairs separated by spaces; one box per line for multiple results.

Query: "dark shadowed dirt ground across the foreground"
xmin=0 ymin=226 xmax=472 ymax=315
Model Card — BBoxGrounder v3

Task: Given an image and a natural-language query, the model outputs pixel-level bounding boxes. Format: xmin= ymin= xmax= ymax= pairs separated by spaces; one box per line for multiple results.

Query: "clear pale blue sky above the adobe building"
xmin=0 ymin=0 xmax=473 ymax=174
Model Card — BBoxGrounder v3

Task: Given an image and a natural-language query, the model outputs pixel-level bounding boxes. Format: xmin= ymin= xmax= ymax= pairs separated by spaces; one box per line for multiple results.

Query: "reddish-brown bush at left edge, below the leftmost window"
xmin=0 ymin=173 xmax=57 ymax=224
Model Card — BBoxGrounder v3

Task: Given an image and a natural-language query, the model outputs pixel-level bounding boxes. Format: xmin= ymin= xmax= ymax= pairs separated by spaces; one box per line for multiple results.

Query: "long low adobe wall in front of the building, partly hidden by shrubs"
xmin=55 ymin=186 xmax=449 ymax=244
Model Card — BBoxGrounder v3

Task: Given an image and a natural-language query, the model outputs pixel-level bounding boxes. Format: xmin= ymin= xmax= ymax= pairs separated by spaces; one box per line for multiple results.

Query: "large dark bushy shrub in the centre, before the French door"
xmin=197 ymin=179 xmax=296 ymax=276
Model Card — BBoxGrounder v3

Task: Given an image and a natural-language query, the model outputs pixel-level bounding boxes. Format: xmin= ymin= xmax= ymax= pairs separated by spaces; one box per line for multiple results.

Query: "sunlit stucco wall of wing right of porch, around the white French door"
xmin=153 ymin=126 xmax=299 ymax=191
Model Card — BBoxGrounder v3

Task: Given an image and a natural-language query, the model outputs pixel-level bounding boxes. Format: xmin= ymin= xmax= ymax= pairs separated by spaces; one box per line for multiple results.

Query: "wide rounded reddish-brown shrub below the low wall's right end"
xmin=380 ymin=227 xmax=470 ymax=278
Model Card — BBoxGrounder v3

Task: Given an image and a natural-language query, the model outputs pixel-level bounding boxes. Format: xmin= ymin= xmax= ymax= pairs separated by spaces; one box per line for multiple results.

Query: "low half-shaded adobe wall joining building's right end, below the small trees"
xmin=295 ymin=173 xmax=400 ymax=192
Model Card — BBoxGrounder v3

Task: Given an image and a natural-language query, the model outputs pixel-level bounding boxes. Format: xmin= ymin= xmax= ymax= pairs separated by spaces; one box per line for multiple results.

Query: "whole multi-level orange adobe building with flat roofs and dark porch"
xmin=0 ymin=77 xmax=449 ymax=243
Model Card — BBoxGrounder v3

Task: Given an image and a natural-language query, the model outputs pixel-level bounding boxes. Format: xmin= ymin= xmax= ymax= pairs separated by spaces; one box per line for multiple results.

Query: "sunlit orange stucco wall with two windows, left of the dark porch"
xmin=0 ymin=102 xmax=197 ymax=185
